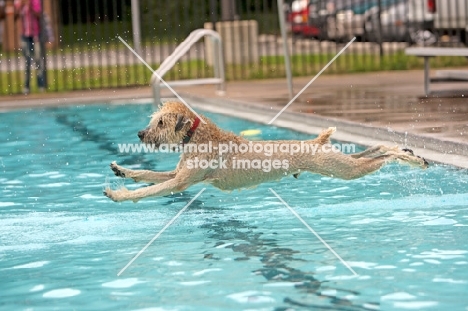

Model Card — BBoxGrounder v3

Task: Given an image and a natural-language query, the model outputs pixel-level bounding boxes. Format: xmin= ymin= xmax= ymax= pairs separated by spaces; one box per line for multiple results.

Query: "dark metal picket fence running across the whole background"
xmin=0 ymin=0 xmax=468 ymax=95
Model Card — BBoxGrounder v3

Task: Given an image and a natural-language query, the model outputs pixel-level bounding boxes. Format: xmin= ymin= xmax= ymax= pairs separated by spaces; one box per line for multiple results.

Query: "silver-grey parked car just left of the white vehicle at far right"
xmin=364 ymin=0 xmax=437 ymax=45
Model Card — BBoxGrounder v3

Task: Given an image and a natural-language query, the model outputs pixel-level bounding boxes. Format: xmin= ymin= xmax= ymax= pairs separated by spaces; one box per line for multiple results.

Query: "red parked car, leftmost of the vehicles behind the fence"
xmin=287 ymin=0 xmax=319 ymax=37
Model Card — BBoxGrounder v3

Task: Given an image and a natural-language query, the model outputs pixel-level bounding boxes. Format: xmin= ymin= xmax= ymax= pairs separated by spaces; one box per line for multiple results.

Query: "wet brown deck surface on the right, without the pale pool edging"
xmin=178 ymin=71 xmax=468 ymax=148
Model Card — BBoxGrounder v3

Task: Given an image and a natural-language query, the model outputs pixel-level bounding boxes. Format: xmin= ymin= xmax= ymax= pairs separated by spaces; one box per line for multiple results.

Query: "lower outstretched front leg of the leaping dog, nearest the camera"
xmin=104 ymin=177 xmax=190 ymax=202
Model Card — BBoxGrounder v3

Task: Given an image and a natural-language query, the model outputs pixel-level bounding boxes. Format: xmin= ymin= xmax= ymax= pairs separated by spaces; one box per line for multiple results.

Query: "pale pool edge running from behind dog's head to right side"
xmin=176 ymin=92 xmax=468 ymax=169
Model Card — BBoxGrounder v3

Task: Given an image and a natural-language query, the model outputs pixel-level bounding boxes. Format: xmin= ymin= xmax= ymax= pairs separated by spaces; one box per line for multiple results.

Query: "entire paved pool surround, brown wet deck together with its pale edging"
xmin=0 ymin=70 xmax=468 ymax=168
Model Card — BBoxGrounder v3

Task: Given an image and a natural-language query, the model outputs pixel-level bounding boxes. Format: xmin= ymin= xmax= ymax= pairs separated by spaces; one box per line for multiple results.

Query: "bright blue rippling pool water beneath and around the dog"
xmin=0 ymin=105 xmax=468 ymax=310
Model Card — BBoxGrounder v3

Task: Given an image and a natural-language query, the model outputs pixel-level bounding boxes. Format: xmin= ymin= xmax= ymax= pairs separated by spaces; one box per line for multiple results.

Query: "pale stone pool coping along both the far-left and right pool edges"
xmin=0 ymin=89 xmax=468 ymax=169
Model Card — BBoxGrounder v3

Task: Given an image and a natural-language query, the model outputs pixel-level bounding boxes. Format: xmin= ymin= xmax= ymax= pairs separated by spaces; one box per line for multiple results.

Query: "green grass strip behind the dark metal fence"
xmin=0 ymin=52 xmax=468 ymax=95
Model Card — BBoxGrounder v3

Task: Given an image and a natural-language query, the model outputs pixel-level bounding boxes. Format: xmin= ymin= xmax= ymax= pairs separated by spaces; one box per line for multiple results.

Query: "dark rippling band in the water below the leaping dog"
xmin=162 ymin=191 xmax=379 ymax=311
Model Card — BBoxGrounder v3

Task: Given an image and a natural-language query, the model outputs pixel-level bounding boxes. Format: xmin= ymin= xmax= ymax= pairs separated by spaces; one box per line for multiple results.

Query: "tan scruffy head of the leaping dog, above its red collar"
xmin=138 ymin=102 xmax=196 ymax=147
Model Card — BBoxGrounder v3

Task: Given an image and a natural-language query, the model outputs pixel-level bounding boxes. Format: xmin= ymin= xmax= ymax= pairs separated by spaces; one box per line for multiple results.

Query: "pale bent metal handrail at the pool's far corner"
xmin=150 ymin=29 xmax=225 ymax=106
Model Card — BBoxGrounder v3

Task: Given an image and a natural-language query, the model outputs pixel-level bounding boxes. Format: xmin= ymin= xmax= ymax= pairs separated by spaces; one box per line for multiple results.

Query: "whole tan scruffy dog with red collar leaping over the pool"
xmin=104 ymin=102 xmax=428 ymax=202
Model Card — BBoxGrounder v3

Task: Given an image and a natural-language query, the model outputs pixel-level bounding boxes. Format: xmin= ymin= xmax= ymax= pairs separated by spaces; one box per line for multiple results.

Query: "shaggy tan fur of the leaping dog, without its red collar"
xmin=104 ymin=102 xmax=428 ymax=202
